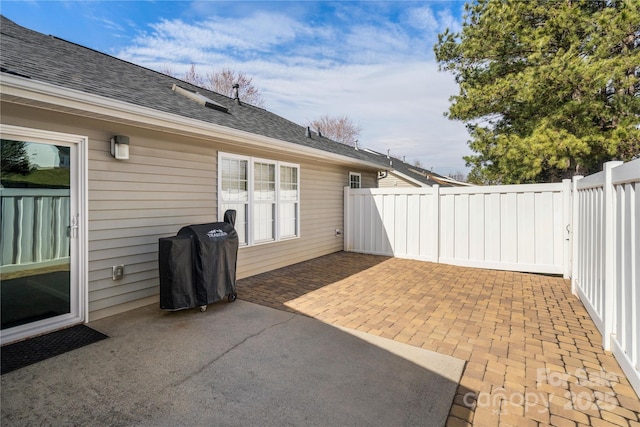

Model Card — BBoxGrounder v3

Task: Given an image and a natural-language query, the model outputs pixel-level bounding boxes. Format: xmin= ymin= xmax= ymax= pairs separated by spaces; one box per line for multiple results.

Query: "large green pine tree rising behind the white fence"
xmin=435 ymin=0 xmax=640 ymax=184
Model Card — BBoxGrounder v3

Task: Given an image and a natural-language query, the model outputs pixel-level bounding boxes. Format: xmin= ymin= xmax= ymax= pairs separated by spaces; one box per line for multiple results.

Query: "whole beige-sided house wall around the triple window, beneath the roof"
xmin=1 ymin=103 xmax=376 ymax=320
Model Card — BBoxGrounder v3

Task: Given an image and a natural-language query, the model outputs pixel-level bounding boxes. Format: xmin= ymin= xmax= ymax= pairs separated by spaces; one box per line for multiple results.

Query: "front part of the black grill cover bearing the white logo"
xmin=176 ymin=222 xmax=238 ymax=306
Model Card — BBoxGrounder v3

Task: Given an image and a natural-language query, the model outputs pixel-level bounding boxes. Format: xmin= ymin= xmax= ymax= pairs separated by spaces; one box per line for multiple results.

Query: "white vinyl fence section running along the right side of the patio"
xmin=571 ymin=159 xmax=640 ymax=394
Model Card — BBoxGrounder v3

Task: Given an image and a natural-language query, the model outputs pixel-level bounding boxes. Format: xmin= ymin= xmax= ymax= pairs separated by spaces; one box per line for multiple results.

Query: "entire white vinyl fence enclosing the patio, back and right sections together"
xmin=344 ymin=159 xmax=640 ymax=395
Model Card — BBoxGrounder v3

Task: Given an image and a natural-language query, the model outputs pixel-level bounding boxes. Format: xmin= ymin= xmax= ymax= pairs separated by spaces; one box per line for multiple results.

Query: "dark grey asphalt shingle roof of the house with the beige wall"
xmin=0 ymin=16 xmax=378 ymax=163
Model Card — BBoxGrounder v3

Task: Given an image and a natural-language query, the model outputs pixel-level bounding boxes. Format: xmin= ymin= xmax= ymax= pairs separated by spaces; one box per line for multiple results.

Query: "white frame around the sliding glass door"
xmin=0 ymin=123 xmax=89 ymax=344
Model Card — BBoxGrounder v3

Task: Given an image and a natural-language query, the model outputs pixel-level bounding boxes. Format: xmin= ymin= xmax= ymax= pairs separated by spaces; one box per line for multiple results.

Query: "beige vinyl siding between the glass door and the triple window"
xmin=89 ymin=131 xmax=217 ymax=318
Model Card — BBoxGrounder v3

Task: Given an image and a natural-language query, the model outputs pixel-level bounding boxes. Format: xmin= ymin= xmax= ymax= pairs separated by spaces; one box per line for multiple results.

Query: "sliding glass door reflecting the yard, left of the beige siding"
xmin=0 ymin=127 xmax=83 ymax=343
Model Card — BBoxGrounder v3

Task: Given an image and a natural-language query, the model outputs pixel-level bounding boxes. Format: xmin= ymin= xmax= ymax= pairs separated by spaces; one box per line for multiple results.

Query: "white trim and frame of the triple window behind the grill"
xmin=217 ymin=151 xmax=300 ymax=248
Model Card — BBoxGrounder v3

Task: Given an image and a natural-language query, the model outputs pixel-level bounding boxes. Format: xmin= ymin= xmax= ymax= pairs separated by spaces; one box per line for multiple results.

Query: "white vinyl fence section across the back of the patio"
xmin=345 ymin=180 xmax=571 ymax=277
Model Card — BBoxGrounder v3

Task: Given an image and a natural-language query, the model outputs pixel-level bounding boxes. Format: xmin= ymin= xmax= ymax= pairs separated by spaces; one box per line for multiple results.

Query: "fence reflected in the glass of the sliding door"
xmin=0 ymin=188 xmax=69 ymax=272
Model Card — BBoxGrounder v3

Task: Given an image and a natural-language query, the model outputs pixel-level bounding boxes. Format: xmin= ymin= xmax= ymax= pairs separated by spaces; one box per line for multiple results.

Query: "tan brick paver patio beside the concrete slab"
xmin=238 ymin=252 xmax=640 ymax=427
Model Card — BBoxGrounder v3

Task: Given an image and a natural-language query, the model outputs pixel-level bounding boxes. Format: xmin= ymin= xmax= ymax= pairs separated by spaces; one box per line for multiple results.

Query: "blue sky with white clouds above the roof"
xmin=0 ymin=0 xmax=471 ymax=174
